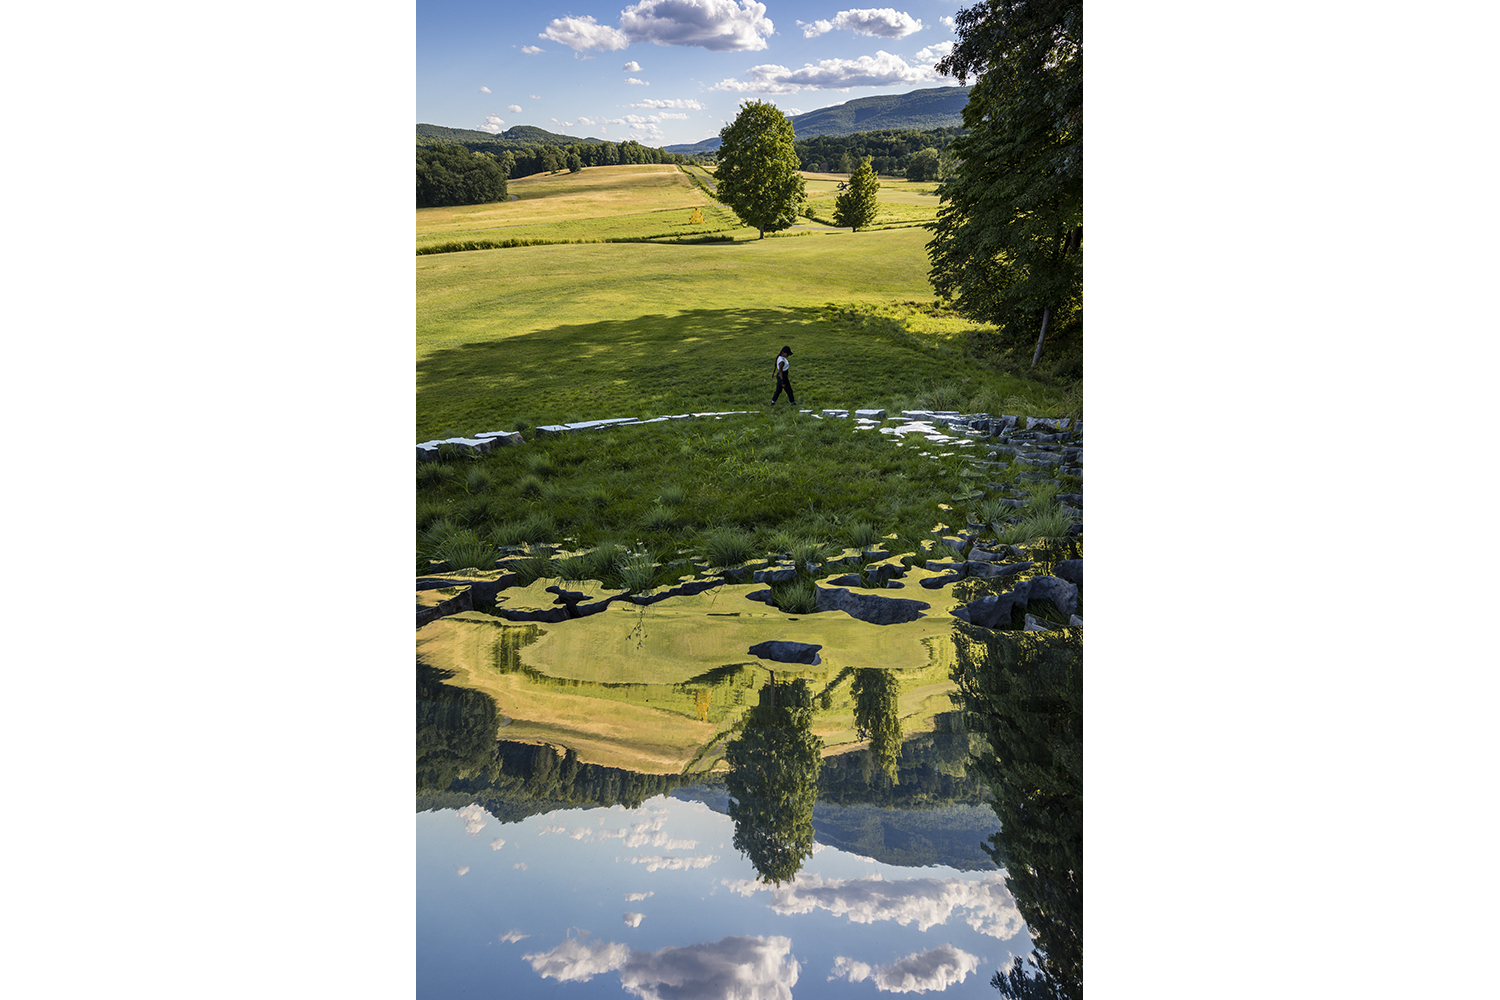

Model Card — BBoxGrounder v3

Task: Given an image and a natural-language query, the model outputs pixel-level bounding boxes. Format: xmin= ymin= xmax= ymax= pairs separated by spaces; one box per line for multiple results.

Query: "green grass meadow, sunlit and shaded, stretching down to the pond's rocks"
xmin=416 ymin=166 xmax=1082 ymax=585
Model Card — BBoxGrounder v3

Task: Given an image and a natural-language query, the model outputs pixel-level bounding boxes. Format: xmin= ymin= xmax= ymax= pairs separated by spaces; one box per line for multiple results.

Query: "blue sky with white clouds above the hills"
xmin=417 ymin=0 xmax=972 ymax=145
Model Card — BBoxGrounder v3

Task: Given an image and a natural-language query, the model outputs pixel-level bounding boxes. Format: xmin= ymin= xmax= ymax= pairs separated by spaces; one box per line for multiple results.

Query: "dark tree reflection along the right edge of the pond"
xmin=954 ymin=622 xmax=1083 ymax=1000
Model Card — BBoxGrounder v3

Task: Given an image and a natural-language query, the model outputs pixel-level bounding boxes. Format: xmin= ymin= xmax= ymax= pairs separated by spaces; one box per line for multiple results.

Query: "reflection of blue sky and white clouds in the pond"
xmin=417 ymin=798 xmax=1031 ymax=1000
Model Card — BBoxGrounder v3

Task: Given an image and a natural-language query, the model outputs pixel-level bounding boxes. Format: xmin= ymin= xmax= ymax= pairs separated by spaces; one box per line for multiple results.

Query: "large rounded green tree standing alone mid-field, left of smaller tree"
xmin=716 ymin=100 xmax=806 ymax=240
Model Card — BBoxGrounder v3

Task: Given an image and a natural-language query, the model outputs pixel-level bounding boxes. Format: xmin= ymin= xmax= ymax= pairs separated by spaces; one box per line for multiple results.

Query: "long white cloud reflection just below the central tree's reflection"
xmin=723 ymin=871 xmax=1025 ymax=942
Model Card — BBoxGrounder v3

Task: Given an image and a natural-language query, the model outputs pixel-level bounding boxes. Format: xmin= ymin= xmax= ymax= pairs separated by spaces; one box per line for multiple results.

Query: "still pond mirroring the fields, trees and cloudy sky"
xmin=417 ymin=544 xmax=1082 ymax=997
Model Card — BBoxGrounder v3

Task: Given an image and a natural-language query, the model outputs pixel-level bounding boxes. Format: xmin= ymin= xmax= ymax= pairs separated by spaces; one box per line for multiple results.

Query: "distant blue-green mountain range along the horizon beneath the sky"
xmin=417 ymin=87 xmax=972 ymax=154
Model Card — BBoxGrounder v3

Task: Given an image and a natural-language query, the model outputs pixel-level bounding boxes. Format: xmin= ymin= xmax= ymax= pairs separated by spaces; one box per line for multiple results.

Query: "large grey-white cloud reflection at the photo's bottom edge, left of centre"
xmin=522 ymin=937 xmax=801 ymax=1000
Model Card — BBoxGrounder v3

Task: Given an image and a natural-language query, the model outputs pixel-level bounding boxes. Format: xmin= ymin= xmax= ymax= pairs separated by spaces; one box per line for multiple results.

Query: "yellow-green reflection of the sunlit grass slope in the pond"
xmin=417 ymin=571 xmax=953 ymax=772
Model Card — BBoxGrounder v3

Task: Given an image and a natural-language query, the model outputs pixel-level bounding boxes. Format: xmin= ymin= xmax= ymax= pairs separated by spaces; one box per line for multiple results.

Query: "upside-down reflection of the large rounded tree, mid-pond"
xmin=725 ymin=675 xmax=824 ymax=885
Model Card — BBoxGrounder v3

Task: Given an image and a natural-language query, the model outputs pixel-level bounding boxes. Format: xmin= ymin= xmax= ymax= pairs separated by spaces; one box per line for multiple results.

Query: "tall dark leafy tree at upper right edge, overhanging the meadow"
xmin=927 ymin=0 xmax=1083 ymax=366
